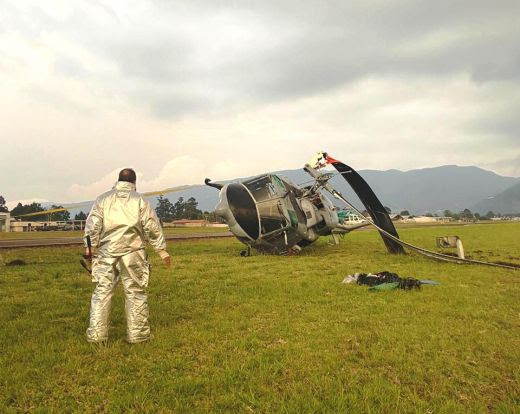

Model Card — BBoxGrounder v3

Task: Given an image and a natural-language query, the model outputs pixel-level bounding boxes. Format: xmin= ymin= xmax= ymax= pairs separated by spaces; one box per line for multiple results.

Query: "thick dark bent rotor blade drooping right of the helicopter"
xmin=327 ymin=156 xmax=404 ymax=254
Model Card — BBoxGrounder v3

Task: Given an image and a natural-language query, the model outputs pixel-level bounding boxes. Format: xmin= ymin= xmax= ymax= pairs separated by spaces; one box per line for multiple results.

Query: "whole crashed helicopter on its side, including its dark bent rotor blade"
xmin=205 ymin=152 xmax=404 ymax=255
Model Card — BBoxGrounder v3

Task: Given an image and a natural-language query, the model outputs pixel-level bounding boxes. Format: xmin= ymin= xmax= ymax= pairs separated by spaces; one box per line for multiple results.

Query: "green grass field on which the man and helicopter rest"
xmin=0 ymin=223 xmax=520 ymax=413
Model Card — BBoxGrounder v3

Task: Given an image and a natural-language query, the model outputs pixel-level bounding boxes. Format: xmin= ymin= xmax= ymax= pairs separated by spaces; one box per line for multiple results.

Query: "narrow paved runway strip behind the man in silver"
xmin=0 ymin=231 xmax=233 ymax=249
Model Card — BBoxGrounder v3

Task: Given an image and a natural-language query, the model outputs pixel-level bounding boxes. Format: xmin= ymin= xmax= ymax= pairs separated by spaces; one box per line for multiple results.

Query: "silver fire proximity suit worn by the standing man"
xmin=85 ymin=181 xmax=168 ymax=343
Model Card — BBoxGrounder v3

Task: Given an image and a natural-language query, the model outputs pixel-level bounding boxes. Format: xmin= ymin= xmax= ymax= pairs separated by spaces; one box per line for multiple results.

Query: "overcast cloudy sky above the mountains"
xmin=0 ymin=0 xmax=520 ymax=205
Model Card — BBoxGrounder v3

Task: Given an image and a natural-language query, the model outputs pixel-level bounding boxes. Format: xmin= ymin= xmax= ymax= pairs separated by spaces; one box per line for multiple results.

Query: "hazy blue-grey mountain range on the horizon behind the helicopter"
xmin=39 ymin=165 xmax=520 ymax=216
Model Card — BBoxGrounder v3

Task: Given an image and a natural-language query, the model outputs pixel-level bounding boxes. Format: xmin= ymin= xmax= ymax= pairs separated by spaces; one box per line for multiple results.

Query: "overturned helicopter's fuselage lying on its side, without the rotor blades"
xmin=206 ymin=174 xmax=361 ymax=254
